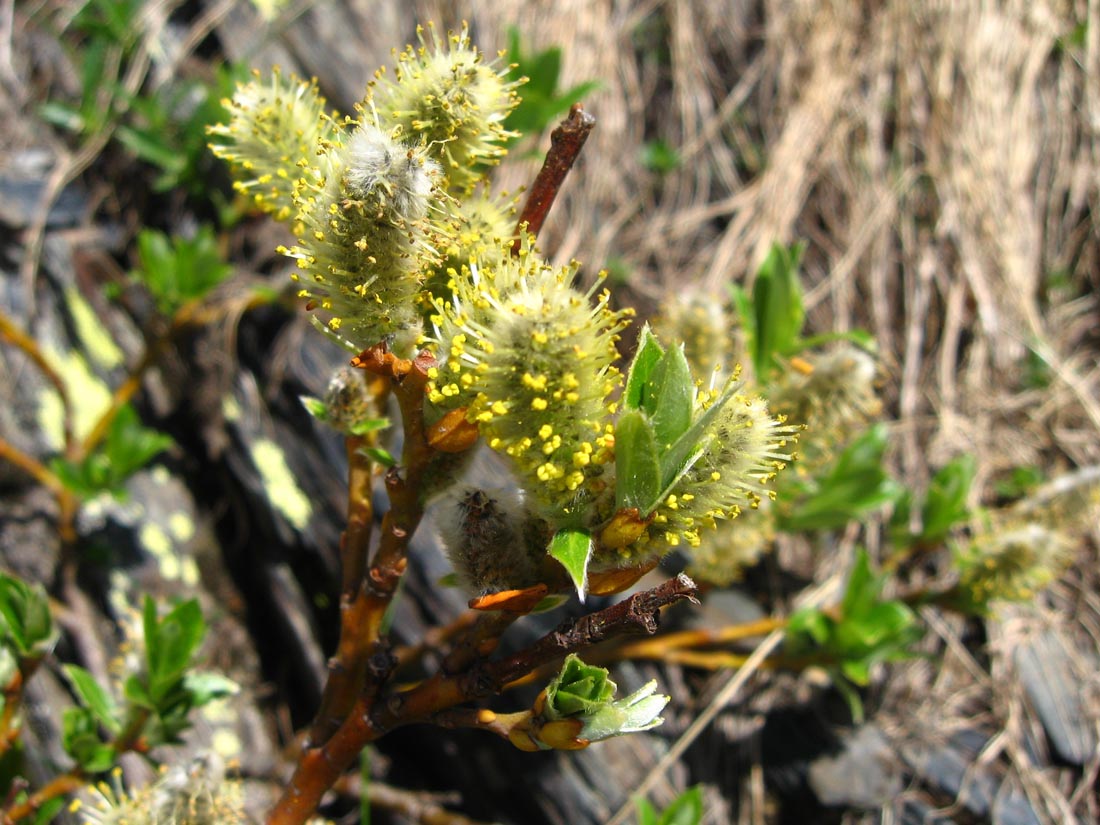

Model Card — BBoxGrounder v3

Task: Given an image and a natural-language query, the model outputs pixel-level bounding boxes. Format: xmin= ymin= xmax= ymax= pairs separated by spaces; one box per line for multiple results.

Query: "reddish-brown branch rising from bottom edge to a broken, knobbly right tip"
xmin=267 ymin=574 xmax=696 ymax=825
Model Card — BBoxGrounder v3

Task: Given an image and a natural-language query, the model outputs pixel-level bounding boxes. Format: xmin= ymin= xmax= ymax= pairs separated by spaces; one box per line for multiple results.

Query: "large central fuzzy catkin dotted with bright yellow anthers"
xmin=428 ymin=235 xmax=626 ymax=526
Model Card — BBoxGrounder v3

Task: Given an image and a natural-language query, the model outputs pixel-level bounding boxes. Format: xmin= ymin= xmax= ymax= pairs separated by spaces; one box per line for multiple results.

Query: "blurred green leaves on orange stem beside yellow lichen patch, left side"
xmin=51 ymin=404 xmax=173 ymax=498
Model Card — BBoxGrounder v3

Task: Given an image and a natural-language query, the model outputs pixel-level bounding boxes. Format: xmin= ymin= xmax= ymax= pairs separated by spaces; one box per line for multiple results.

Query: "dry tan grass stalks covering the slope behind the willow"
xmin=0 ymin=0 xmax=1100 ymax=822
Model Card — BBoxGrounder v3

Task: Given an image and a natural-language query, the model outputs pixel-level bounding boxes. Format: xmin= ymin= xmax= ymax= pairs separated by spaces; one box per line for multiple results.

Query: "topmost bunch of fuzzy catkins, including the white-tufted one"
xmin=211 ymin=29 xmax=518 ymax=351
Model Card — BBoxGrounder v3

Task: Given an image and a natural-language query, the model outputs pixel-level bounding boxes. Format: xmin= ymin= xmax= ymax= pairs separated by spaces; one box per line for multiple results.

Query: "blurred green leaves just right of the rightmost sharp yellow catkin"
xmin=777 ymin=424 xmax=903 ymax=532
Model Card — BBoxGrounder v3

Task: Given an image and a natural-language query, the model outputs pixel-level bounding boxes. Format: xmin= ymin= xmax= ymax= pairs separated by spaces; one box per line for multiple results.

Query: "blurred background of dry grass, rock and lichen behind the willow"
xmin=0 ymin=0 xmax=1100 ymax=823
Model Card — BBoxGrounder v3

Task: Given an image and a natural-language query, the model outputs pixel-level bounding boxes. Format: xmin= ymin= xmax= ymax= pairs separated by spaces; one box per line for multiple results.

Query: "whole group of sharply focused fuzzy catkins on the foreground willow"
xmin=211 ymin=26 xmax=793 ymax=593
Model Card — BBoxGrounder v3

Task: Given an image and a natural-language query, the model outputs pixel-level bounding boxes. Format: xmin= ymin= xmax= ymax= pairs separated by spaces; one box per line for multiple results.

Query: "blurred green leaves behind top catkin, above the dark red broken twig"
xmin=504 ymin=26 xmax=600 ymax=143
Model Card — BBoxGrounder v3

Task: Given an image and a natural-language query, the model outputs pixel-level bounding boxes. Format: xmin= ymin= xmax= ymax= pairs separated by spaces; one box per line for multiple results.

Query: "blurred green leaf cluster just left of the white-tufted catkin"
xmin=133 ymin=224 xmax=233 ymax=316
